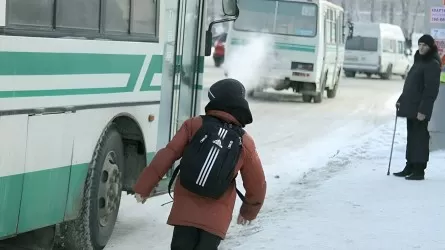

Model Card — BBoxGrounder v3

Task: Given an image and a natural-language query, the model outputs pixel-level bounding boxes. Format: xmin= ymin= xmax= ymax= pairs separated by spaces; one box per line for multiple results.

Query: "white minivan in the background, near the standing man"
xmin=343 ymin=22 xmax=411 ymax=79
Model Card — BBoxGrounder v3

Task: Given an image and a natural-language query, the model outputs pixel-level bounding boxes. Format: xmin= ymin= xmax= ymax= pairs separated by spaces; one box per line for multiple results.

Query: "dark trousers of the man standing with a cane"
xmin=406 ymin=119 xmax=430 ymax=164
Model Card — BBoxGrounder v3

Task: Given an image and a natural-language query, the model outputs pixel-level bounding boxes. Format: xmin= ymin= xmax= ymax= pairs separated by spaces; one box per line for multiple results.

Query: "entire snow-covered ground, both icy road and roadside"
xmin=106 ymin=67 xmax=445 ymax=250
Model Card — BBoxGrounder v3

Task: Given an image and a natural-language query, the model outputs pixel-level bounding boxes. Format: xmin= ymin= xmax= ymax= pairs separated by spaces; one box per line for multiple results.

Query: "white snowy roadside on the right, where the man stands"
xmin=219 ymin=118 xmax=445 ymax=250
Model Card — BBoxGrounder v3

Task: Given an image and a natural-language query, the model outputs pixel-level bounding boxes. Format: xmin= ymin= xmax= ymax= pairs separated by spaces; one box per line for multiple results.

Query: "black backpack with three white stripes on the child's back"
xmin=168 ymin=115 xmax=245 ymax=202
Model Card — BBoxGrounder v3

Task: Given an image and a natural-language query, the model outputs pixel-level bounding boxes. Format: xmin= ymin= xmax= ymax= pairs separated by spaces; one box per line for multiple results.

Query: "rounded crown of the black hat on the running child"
xmin=208 ymin=78 xmax=246 ymax=100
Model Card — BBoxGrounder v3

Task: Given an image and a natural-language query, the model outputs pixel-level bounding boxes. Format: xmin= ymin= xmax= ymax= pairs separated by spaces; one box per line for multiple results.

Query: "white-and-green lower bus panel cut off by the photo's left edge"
xmin=0 ymin=115 xmax=28 ymax=239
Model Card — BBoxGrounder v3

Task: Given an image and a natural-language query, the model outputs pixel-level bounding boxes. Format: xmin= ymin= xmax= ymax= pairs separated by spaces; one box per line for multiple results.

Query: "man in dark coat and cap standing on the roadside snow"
xmin=394 ymin=35 xmax=441 ymax=180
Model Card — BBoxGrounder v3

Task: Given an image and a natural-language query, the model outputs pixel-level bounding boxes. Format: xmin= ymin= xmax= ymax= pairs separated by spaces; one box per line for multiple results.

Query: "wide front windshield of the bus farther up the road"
xmin=234 ymin=0 xmax=318 ymax=37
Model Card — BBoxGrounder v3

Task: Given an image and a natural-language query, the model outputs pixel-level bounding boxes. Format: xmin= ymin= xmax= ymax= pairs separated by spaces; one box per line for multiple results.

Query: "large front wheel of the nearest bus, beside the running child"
xmin=61 ymin=125 xmax=124 ymax=250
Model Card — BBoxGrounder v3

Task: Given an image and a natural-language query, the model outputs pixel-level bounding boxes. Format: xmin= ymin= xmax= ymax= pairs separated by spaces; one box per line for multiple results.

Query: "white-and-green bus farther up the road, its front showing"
xmin=226 ymin=0 xmax=352 ymax=103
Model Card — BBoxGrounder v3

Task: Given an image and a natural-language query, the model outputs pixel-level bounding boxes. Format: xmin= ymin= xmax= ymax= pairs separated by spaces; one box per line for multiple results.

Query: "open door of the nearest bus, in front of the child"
xmin=155 ymin=0 xmax=204 ymax=193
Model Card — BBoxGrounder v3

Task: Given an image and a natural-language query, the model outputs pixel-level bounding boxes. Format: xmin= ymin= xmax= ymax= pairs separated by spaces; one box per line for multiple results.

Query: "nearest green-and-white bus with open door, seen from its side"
xmin=0 ymin=0 xmax=238 ymax=250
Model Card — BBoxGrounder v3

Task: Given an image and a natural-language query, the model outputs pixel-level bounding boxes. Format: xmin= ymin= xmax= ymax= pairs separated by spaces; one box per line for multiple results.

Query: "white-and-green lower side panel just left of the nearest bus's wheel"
xmin=18 ymin=113 xmax=75 ymax=233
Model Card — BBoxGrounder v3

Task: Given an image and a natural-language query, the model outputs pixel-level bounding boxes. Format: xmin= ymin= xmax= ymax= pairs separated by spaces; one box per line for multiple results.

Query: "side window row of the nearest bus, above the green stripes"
xmin=4 ymin=0 xmax=160 ymax=42
